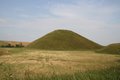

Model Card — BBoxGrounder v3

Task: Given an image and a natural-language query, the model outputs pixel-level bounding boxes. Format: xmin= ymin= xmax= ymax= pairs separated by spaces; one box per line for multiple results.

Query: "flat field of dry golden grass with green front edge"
xmin=0 ymin=48 xmax=120 ymax=80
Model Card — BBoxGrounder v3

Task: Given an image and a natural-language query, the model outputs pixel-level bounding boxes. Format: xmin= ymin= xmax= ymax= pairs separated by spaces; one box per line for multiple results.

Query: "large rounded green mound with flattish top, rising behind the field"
xmin=27 ymin=30 xmax=101 ymax=50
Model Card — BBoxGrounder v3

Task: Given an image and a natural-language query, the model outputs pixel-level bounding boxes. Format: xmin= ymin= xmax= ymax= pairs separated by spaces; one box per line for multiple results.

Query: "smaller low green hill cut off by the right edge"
xmin=97 ymin=43 xmax=120 ymax=54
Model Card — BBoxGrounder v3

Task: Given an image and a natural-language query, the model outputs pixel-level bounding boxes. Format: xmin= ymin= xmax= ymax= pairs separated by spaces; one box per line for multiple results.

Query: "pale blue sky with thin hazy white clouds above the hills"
xmin=0 ymin=0 xmax=120 ymax=45
